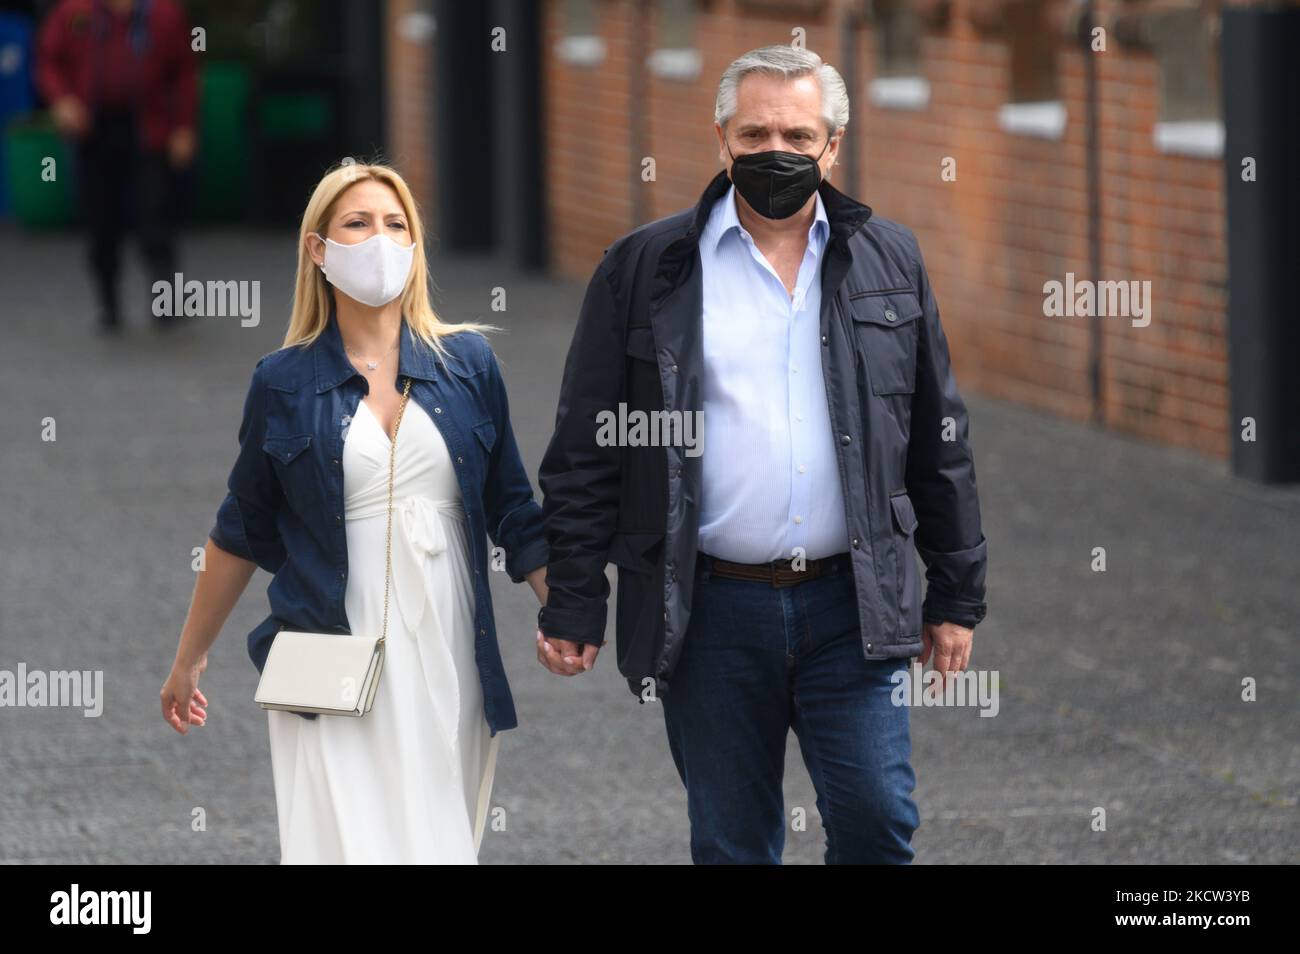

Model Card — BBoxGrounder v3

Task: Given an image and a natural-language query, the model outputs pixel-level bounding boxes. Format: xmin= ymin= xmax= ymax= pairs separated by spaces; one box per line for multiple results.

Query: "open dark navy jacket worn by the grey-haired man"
xmin=538 ymin=172 xmax=987 ymax=694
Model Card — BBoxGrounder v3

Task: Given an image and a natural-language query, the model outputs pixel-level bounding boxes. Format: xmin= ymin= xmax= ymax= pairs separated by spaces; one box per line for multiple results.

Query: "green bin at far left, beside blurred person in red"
xmin=4 ymin=113 xmax=77 ymax=229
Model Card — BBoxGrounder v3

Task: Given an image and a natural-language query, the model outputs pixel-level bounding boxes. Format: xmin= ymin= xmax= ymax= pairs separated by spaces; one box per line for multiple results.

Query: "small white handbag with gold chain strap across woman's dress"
xmin=254 ymin=378 xmax=411 ymax=716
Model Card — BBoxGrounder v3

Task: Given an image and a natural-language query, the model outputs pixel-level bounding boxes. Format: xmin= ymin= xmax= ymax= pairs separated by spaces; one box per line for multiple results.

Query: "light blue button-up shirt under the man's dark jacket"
xmin=699 ymin=186 xmax=849 ymax=563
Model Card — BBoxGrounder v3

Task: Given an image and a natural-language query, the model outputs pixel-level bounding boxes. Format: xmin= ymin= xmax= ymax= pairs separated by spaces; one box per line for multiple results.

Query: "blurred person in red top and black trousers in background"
xmin=35 ymin=0 xmax=198 ymax=333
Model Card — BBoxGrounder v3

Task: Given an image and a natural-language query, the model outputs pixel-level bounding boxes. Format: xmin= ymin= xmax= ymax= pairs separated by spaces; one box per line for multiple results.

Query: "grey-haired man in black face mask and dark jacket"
xmin=538 ymin=47 xmax=985 ymax=863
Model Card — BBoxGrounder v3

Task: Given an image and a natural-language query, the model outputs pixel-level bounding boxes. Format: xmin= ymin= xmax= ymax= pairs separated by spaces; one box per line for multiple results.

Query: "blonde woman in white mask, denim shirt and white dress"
xmin=161 ymin=165 xmax=547 ymax=864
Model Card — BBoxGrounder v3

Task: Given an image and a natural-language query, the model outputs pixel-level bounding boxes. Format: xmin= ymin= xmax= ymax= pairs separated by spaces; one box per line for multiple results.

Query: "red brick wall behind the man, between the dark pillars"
xmin=543 ymin=0 xmax=1229 ymax=458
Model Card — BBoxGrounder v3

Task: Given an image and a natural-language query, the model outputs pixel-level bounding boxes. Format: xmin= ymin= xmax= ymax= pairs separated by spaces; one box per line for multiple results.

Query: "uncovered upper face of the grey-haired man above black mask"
xmin=714 ymin=73 xmax=840 ymax=178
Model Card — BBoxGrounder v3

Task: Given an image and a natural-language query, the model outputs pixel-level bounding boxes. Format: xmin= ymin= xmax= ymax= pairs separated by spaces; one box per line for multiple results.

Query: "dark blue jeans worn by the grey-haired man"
xmin=662 ymin=554 xmax=920 ymax=864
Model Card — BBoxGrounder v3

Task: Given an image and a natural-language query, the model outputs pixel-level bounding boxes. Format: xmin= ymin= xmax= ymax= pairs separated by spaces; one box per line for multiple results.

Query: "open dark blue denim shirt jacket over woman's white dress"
xmin=211 ymin=309 xmax=549 ymax=736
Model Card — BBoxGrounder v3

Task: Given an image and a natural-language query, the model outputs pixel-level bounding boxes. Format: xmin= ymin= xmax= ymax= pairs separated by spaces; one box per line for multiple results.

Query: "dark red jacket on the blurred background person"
xmin=36 ymin=0 xmax=198 ymax=149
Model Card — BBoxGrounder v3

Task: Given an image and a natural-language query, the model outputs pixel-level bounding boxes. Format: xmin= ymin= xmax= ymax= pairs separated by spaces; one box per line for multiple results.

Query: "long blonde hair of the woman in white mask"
xmin=283 ymin=161 xmax=501 ymax=355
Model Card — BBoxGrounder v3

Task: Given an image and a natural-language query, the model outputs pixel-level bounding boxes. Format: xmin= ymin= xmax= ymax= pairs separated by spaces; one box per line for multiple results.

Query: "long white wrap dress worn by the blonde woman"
xmin=267 ymin=399 xmax=501 ymax=864
